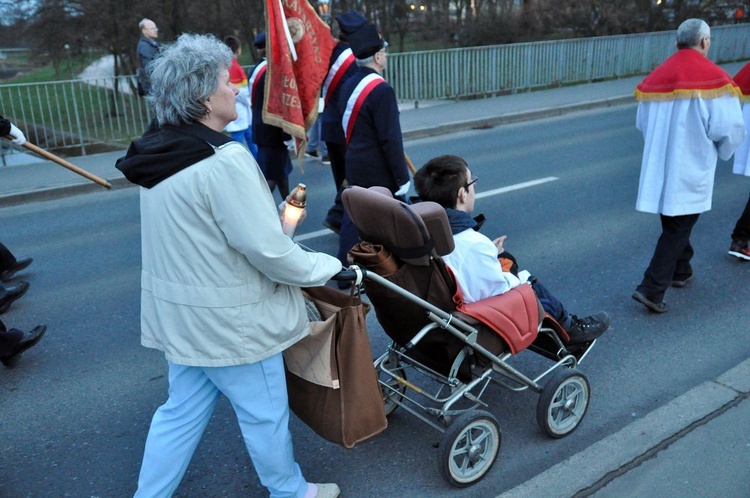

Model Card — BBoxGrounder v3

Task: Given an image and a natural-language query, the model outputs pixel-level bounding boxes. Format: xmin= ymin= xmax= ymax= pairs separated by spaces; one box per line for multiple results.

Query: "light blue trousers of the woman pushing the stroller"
xmin=135 ymin=353 xmax=307 ymax=498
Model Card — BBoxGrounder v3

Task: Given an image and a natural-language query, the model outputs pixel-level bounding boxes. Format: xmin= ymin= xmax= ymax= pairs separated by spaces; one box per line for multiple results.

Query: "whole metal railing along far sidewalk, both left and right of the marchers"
xmin=0 ymin=24 xmax=750 ymax=154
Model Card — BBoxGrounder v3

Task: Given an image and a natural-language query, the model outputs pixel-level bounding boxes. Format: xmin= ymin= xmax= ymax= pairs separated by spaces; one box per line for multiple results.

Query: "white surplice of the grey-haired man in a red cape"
xmin=636 ymin=95 xmax=745 ymax=216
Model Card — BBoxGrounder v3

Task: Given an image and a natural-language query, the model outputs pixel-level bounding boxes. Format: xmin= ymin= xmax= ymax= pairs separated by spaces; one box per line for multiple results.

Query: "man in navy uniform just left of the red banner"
xmin=248 ymin=33 xmax=292 ymax=201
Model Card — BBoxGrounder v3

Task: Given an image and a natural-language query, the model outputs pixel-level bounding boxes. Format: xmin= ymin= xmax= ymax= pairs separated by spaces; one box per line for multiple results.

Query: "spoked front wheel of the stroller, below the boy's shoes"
xmin=536 ymin=368 xmax=591 ymax=439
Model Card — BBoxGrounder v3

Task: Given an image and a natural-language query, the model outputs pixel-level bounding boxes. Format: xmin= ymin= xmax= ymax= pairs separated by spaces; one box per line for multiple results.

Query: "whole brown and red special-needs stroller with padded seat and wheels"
xmin=339 ymin=187 xmax=596 ymax=487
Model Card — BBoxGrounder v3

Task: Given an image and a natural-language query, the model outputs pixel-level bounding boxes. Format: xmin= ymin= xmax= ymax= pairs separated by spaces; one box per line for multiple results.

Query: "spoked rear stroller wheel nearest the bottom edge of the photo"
xmin=438 ymin=410 xmax=501 ymax=488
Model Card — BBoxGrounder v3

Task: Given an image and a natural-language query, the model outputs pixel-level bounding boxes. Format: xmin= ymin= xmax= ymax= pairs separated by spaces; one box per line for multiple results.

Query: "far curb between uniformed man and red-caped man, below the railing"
xmin=402 ymin=94 xmax=635 ymax=140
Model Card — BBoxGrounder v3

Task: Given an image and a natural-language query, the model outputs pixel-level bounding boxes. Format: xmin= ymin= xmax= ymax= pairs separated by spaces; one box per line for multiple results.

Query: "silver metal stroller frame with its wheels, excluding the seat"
xmin=349 ymin=265 xmax=596 ymax=487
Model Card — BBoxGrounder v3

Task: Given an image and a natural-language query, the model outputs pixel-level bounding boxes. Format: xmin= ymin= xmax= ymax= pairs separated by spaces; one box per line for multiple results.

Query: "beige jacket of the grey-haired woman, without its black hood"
xmin=141 ymin=142 xmax=341 ymax=367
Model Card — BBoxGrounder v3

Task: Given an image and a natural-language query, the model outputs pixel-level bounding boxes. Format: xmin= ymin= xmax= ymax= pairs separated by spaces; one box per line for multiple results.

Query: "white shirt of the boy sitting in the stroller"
xmin=443 ymin=228 xmax=521 ymax=303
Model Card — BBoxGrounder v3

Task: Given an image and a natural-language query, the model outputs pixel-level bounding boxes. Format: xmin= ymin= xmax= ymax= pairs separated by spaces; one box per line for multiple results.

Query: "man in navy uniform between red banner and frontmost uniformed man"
xmin=320 ymin=10 xmax=367 ymax=233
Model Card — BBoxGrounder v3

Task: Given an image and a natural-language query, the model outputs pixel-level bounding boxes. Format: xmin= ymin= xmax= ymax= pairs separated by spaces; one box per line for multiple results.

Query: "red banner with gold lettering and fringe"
xmin=263 ymin=0 xmax=335 ymax=156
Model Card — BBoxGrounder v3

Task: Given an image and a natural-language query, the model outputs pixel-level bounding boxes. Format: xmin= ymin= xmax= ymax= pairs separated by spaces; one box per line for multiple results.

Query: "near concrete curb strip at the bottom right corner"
xmin=498 ymin=359 xmax=750 ymax=498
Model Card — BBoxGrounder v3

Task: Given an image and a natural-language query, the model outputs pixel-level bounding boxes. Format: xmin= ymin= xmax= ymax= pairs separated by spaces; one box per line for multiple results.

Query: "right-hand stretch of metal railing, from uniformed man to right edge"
xmin=386 ymin=25 xmax=750 ymax=101
